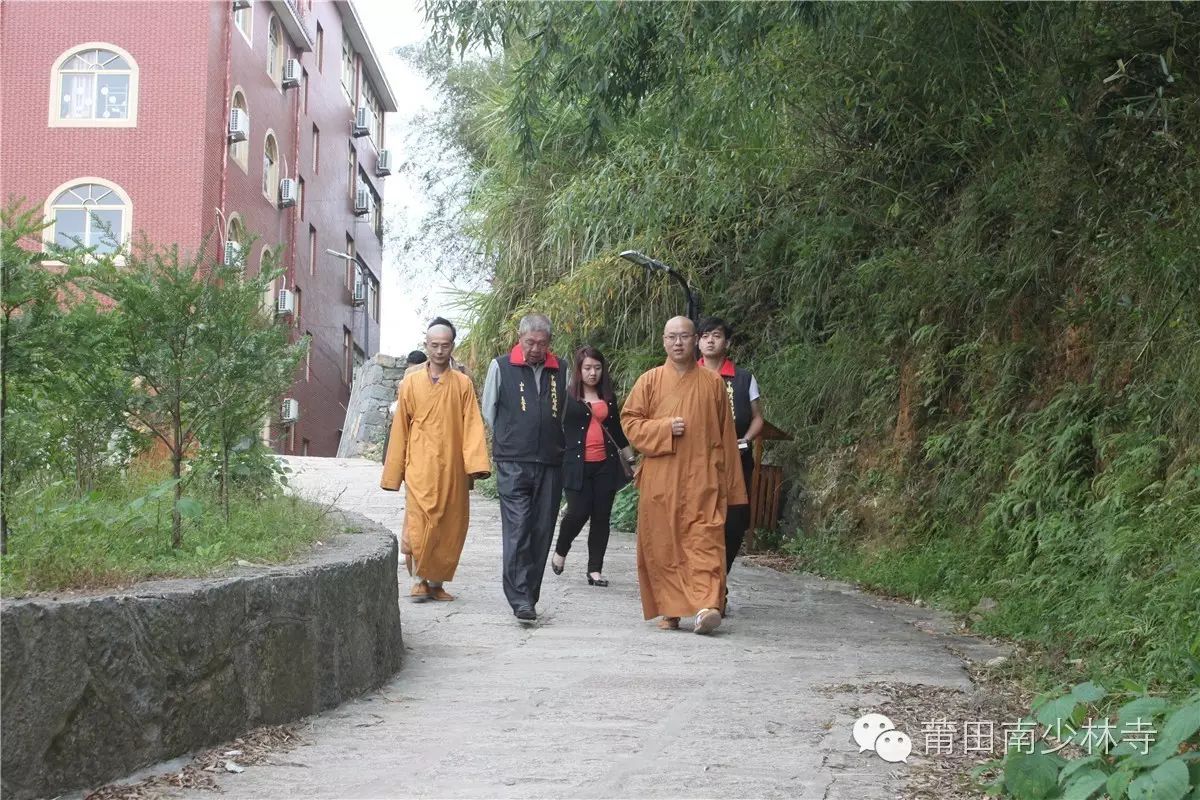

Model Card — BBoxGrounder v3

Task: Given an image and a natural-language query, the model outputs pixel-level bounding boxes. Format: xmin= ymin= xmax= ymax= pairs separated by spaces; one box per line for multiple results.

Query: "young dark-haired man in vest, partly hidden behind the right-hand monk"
xmin=696 ymin=317 xmax=763 ymax=614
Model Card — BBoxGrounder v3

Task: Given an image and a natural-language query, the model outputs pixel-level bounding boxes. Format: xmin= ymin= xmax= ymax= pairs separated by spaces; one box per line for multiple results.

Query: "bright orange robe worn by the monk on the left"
xmin=379 ymin=365 xmax=492 ymax=582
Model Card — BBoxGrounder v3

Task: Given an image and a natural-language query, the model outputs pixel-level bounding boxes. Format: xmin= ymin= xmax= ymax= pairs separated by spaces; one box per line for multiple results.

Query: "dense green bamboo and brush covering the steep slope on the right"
xmin=428 ymin=0 xmax=1200 ymax=686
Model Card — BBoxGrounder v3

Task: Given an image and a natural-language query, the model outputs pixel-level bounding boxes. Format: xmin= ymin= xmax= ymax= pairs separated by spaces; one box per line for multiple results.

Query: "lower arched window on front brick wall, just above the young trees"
xmin=46 ymin=178 xmax=131 ymax=253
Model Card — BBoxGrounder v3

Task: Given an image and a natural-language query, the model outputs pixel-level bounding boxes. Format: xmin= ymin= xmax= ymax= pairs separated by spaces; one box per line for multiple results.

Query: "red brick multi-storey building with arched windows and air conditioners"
xmin=0 ymin=0 xmax=396 ymax=456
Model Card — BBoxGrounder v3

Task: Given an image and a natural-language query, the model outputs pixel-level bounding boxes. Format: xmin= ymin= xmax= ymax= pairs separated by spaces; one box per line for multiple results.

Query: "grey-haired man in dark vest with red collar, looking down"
xmin=482 ymin=314 xmax=566 ymax=622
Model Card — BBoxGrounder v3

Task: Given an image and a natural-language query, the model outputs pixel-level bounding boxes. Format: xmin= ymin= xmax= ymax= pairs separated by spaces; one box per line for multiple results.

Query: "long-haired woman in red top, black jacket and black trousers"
xmin=550 ymin=347 xmax=634 ymax=587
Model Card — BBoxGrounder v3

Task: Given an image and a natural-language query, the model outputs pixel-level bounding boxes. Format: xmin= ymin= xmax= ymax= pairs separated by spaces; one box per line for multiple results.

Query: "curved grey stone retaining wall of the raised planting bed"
xmin=0 ymin=515 xmax=403 ymax=800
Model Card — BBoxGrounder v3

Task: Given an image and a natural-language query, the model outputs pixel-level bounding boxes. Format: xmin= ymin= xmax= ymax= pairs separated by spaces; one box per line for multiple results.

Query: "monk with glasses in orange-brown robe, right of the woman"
xmin=620 ymin=317 xmax=748 ymax=633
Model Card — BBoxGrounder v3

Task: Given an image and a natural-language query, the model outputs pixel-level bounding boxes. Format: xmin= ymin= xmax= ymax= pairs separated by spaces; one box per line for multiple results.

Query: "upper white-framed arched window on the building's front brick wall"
xmin=50 ymin=42 xmax=138 ymax=127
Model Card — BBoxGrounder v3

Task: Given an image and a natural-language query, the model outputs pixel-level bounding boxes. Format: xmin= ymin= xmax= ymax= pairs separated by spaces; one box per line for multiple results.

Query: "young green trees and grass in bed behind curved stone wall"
xmin=0 ymin=203 xmax=312 ymax=591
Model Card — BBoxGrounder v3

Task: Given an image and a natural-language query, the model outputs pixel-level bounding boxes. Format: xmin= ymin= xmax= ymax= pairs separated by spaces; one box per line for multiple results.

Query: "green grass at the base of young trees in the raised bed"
xmin=0 ymin=475 xmax=334 ymax=596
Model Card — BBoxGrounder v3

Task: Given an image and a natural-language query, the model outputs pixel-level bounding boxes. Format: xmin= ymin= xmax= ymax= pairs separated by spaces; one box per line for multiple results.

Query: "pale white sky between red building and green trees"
xmin=355 ymin=0 xmax=478 ymax=355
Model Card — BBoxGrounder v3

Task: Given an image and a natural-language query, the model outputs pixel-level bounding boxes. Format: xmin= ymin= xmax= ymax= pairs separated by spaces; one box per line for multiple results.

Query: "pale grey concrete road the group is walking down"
xmin=174 ymin=458 xmax=1003 ymax=800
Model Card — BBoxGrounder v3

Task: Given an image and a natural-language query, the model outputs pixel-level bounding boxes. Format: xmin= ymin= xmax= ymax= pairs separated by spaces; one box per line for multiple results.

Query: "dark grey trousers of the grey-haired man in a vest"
xmin=496 ymin=461 xmax=563 ymax=610
